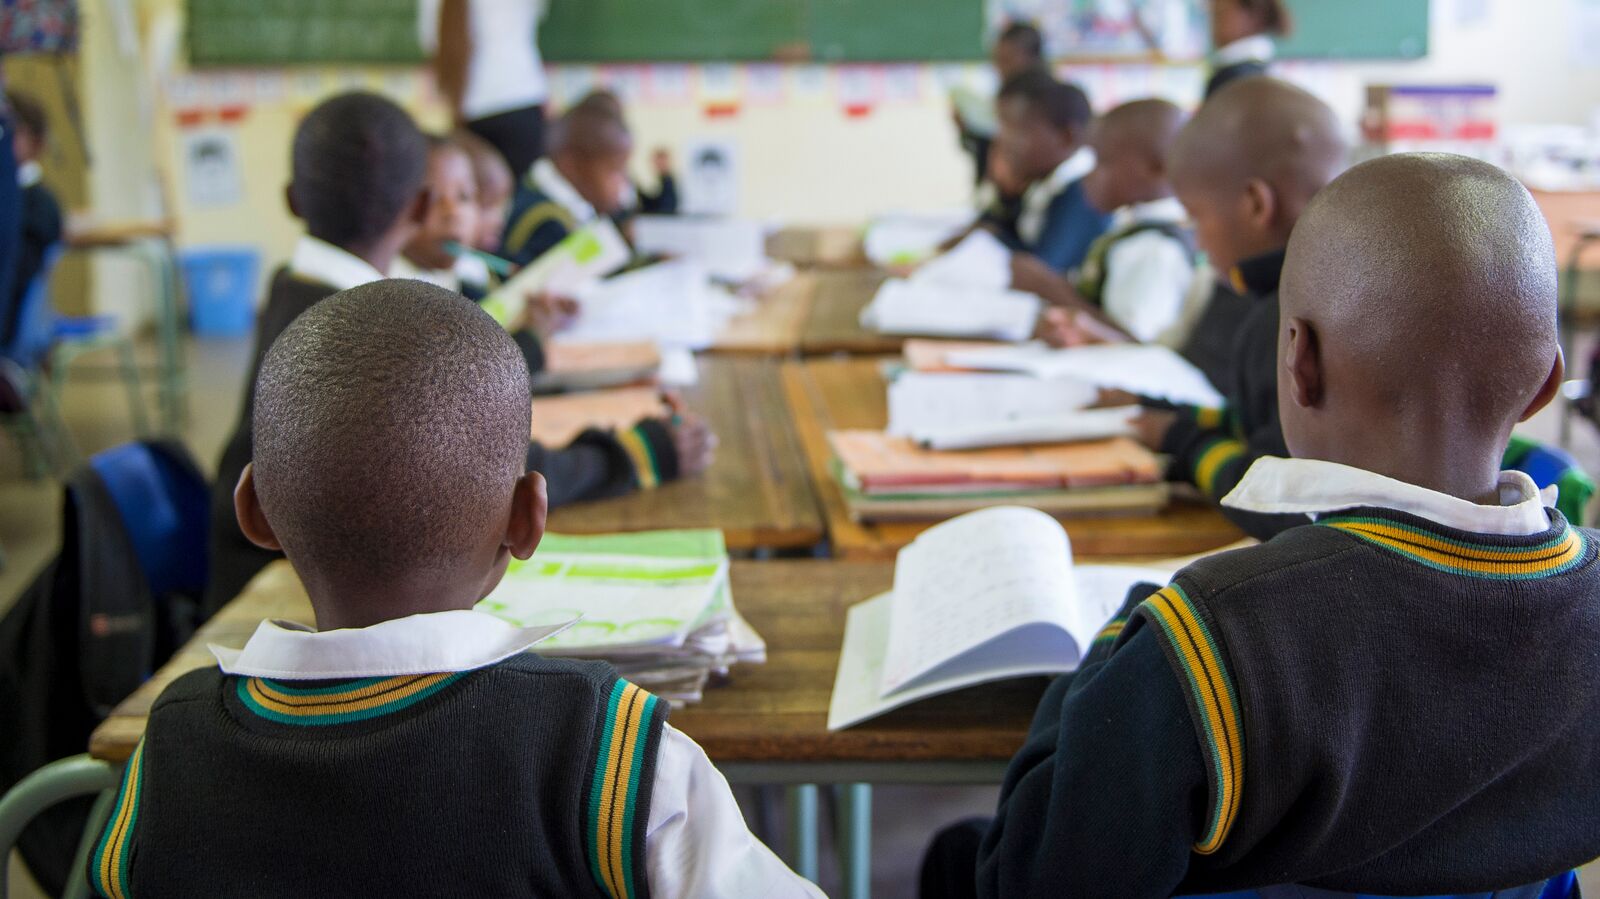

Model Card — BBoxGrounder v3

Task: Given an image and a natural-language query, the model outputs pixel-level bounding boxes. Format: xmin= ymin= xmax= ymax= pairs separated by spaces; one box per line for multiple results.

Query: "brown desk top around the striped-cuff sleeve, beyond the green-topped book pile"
xmin=549 ymin=357 xmax=822 ymax=550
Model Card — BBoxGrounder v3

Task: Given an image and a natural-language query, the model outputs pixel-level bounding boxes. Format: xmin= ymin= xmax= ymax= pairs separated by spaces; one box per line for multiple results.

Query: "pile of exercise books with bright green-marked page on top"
xmin=478 ymin=529 xmax=766 ymax=705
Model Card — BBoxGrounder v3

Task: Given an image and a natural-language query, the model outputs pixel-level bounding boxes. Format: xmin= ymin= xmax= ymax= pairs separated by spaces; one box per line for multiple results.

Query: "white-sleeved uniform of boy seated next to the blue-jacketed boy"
xmin=1077 ymin=197 xmax=1195 ymax=342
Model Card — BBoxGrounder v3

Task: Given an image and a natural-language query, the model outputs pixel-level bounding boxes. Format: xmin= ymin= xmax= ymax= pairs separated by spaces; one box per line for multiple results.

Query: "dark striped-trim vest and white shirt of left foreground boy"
xmin=90 ymin=609 xmax=822 ymax=899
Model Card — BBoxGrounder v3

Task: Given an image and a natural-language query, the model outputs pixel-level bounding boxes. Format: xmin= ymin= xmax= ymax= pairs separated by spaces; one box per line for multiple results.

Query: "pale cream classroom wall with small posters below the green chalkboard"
xmin=68 ymin=0 xmax=1600 ymax=318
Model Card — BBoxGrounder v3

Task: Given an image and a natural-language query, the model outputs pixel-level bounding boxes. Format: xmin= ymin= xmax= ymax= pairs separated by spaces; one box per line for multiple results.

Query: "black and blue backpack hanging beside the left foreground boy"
xmin=0 ymin=443 xmax=208 ymax=893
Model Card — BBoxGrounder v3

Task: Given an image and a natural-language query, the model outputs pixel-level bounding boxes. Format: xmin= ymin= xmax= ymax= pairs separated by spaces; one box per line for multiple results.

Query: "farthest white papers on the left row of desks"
xmin=634 ymin=216 xmax=794 ymax=290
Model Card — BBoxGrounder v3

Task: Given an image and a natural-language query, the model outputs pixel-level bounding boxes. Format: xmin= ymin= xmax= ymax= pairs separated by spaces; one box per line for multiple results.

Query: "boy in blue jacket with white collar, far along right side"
xmin=995 ymin=69 xmax=1110 ymax=274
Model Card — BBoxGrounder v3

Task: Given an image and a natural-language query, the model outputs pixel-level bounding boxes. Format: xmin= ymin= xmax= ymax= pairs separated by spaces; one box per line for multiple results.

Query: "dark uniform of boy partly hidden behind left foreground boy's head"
xmin=202 ymin=237 xmax=678 ymax=616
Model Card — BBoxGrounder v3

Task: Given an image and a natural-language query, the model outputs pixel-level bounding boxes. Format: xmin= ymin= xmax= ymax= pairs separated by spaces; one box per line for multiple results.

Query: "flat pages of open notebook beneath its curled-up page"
xmin=827 ymin=565 xmax=1170 ymax=731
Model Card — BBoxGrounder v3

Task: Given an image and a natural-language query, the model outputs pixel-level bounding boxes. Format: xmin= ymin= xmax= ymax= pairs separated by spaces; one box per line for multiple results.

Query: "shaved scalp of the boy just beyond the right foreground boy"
xmin=1171 ymin=77 xmax=1346 ymax=206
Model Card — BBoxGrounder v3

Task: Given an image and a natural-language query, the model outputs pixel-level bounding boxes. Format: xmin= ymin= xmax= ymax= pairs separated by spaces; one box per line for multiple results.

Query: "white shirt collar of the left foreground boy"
xmin=206 ymin=609 xmax=573 ymax=680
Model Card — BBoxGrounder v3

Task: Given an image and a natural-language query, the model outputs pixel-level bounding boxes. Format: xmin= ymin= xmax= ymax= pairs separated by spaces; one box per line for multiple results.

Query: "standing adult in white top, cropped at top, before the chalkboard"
xmin=418 ymin=0 xmax=549 ymax=178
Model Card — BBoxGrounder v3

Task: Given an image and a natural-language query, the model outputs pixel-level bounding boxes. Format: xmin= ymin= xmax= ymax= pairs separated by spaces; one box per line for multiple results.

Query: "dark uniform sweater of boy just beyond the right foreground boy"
xmin=1160 ymin=250 xmax=1304 ymax=539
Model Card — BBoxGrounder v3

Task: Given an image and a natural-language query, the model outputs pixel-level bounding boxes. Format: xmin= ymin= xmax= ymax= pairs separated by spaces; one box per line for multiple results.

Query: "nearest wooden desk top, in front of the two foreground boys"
xmin=90 ymin=560 xmax=1045 ymax=763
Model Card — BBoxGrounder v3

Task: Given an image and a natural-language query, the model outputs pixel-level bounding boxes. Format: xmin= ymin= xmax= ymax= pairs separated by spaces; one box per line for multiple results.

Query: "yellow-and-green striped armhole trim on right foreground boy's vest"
xmin=1139 ymin=584 xmax=1245 ymax=856
